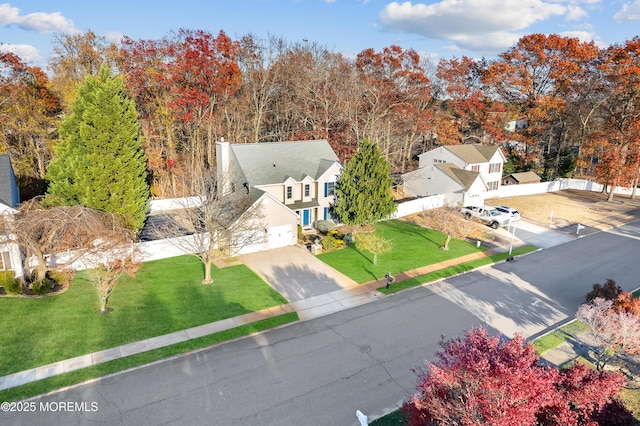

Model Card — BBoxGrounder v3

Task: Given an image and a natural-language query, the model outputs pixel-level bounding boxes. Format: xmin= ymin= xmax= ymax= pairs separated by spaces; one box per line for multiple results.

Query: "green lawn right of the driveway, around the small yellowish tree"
xmin=318 ymin=220 xmax=485 ymax=284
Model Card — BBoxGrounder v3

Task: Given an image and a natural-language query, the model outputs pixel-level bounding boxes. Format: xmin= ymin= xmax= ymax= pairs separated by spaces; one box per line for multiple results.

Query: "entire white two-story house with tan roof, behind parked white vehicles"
xmin=403 ymin=144 xmax=505 ymax=205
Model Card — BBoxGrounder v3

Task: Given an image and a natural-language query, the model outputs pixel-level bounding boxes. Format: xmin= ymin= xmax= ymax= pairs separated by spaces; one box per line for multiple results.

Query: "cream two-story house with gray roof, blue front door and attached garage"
xmin=216 ymin=140 xmax=342 ymax=253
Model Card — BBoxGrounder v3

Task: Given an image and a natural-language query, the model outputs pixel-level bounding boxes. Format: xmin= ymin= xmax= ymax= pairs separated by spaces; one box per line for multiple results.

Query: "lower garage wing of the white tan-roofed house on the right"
xmin=402 ymin=163 xmax=487 ymax=206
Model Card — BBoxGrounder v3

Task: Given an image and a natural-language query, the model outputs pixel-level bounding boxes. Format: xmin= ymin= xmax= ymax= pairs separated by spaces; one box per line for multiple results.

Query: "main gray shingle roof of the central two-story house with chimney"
xmin=229 ymin=140 xmax=338 ymax=186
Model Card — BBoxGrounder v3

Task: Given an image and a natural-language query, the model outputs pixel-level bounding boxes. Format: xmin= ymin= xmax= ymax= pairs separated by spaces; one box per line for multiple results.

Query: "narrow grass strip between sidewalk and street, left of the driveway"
xmin=0 ymin=312 xmax=298 ymax=401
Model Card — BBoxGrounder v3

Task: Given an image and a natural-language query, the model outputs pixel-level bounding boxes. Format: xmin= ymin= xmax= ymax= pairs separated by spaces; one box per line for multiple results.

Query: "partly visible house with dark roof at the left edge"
xmin=0 ymin=154 xmax=24 ymax=277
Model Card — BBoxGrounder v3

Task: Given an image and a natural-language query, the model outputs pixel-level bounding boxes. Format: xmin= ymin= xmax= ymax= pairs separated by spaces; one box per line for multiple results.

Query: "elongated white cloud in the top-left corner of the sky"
xmin=0 ymin=3 xmax=78 ymax=33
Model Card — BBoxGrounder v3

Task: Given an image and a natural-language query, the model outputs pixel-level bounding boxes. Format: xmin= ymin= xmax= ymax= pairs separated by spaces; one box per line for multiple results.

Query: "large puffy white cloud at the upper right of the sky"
xmin=380 ymin=0 xmax=584 ymax=53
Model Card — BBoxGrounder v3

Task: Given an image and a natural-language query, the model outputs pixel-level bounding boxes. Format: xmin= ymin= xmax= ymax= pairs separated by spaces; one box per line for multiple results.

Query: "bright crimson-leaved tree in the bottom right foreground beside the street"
xmin=403 ymin=328 xmax=624 ymax=426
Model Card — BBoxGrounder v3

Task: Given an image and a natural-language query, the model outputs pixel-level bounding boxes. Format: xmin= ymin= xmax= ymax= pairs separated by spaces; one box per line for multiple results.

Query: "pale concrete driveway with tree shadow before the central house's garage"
xmin=240 ymin=246 xmax=358 ymax=302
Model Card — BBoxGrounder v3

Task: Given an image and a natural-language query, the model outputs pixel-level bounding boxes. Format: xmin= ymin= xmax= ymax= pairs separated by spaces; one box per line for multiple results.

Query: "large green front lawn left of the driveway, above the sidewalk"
xmin=0 ymin=256 xmax=287 ymax=376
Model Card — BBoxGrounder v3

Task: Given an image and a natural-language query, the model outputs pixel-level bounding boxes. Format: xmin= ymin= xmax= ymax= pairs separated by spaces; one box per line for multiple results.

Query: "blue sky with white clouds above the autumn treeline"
xmin=0 ymin=0 xmax=640 ymax=67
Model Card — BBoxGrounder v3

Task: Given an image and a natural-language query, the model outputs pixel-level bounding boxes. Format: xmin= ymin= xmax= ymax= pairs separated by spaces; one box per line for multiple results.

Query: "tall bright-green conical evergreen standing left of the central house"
xmin=47 ymin=66 xmax=149 ymax=232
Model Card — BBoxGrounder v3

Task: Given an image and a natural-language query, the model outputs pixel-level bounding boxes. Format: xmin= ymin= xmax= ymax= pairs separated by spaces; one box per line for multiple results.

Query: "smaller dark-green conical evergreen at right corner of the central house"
xmin=333 ymin=139 xmax=396 ymax=225
